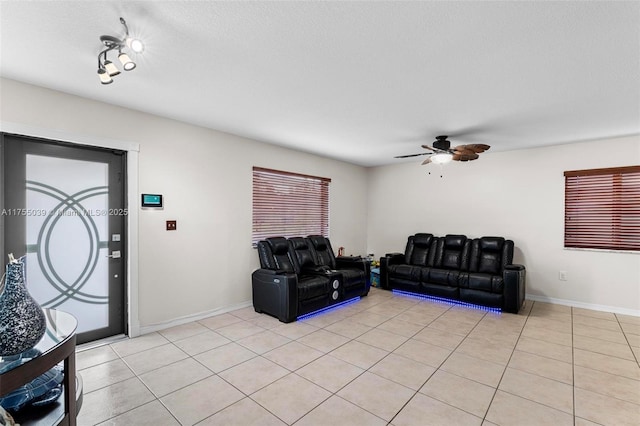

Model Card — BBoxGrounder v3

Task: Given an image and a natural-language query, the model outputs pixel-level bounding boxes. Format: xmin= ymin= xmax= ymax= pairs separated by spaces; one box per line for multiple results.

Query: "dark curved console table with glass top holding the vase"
xmin=0 ymin=309 xmax=82 ymax=426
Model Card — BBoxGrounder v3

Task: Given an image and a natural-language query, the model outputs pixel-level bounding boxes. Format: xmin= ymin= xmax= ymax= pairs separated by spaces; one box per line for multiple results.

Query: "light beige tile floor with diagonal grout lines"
xmin=77 ymin=289 xmax=640 ymax=426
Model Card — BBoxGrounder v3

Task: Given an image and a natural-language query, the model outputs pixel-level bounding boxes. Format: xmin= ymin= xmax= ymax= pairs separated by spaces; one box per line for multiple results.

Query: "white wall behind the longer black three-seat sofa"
xmin=368 ymin=136 xmax=640 ymax=315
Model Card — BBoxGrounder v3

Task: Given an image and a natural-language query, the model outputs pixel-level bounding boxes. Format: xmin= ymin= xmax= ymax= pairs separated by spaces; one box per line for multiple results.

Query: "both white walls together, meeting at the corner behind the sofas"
xmin=0 ymin=79 xmax=640 ymax=320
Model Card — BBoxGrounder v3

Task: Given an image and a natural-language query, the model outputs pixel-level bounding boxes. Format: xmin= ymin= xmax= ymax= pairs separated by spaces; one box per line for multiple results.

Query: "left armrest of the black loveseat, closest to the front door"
xmin=251 ymin=269 xmax=298 ymax=323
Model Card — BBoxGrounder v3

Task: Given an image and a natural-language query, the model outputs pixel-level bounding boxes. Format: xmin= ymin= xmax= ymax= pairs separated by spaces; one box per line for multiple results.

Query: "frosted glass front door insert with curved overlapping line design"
xmin=26 ymin=154 xmax=109 ymax=333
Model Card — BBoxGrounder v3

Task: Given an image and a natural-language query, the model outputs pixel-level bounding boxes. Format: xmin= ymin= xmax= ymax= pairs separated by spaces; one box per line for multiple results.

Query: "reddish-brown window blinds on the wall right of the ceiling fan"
xmin=564 ymin=166 xmax=640 ymax=251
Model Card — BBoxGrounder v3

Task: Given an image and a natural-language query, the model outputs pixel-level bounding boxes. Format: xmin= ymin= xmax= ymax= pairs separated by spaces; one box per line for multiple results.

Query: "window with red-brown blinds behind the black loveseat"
xmin=252 ymin=167 xmax=331 ymax=245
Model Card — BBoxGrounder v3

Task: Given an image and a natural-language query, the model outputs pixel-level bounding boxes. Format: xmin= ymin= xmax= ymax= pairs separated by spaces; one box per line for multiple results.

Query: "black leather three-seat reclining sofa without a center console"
xmin=380 ymin=233 xmax=526 ymax=313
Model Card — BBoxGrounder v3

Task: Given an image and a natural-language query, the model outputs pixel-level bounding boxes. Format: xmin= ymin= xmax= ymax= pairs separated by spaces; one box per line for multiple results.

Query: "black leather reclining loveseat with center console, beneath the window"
xmin=251 ymin=235 xmax=371 ymax=322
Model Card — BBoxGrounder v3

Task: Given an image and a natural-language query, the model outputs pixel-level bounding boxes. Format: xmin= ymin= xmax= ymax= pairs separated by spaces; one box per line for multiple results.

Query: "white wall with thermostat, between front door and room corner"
xmin=0 ymin=79 xmax=367 ymax=329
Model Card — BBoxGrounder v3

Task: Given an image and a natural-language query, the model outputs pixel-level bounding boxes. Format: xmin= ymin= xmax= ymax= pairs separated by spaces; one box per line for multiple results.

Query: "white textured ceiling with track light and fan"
xmin=0 ymin=0 xmax=640 ymax=166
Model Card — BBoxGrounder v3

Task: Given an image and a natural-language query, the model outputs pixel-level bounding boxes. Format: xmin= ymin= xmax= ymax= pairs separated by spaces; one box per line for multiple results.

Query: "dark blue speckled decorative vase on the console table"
xmin=0 ymin=257 xmax=47 ymax=356
